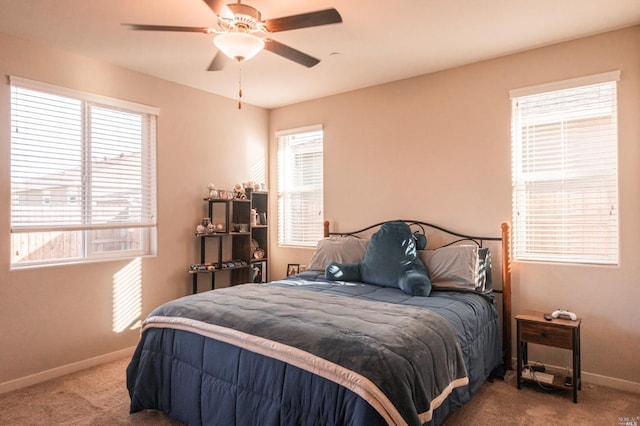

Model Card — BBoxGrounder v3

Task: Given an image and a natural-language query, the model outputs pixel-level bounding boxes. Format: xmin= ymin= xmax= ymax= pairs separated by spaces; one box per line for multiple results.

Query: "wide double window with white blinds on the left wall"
xmin=11 ymin=76 xmax=158 ymax=268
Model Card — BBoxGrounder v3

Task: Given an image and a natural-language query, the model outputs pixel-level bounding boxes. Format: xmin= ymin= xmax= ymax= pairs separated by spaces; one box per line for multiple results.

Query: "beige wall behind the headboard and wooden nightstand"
xmin=270 ymin=26 xmax=640 ymax=391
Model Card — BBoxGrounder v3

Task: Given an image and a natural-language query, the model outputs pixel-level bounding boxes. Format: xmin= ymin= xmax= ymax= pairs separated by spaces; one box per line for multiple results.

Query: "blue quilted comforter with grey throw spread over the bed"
xmin=127 ymin=273 xmax=500 ymax=424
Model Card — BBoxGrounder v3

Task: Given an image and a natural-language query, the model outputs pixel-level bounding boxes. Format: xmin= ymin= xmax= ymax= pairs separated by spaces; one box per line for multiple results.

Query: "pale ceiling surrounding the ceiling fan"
xmin=0 ymin=0 xmax=640 ymax=108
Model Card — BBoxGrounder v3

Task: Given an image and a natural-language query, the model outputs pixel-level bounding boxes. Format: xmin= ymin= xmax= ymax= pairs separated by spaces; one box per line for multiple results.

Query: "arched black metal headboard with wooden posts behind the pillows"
xmin=324 ymin=219 xmax=512 ymax=370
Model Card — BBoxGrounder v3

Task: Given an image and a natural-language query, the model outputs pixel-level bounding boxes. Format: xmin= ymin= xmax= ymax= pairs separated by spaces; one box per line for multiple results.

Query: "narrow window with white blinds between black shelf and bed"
xmin=276 ymin=126 xmax=324 ymax=247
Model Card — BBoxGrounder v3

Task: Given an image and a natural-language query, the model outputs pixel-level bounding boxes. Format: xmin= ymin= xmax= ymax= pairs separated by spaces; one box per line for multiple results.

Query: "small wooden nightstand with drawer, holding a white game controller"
xmin=516 ymin=311 xmax=582 ymax=403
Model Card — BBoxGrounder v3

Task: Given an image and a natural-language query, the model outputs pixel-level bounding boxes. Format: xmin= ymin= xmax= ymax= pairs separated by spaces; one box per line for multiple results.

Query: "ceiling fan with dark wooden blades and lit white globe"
xmin=122 ymin=0 xmax=342 ymax=71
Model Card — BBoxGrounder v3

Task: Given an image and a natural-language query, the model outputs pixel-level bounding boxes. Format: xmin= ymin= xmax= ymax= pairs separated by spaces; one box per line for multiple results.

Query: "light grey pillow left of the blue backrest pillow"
xmin=307 ymin=237 xmax=369 ymax=271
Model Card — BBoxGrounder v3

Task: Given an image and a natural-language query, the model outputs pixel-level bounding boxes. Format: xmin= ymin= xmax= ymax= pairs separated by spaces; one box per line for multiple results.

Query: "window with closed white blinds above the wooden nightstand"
xmin=511 ymin=71 xmax=620 ymax=264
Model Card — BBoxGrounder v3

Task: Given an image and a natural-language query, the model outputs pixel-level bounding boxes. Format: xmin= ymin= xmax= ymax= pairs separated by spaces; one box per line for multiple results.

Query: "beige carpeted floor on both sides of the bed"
xmin=0 ymin=359 xmax=640 ymax=426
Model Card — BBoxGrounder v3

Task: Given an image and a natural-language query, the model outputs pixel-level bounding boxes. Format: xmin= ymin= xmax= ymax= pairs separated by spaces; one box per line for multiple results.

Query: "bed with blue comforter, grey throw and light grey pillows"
xmin=127 ymin=220 xmax=511 ymax=425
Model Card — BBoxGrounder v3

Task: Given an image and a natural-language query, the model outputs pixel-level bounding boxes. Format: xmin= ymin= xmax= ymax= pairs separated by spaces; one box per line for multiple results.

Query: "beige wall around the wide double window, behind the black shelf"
xmin=0 ymin=34 xmax=269 ymax=392
